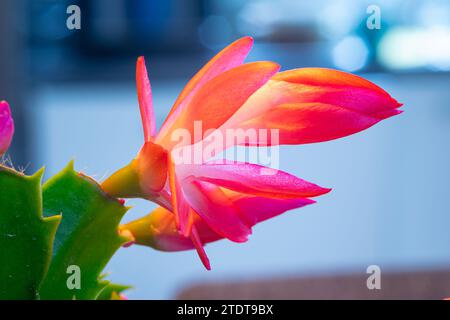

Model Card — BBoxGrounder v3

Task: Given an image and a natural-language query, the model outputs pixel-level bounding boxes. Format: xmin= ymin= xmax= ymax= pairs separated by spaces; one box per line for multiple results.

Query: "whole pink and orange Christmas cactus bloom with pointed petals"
xmin=102 ymin=37 xmax=401 ymax=269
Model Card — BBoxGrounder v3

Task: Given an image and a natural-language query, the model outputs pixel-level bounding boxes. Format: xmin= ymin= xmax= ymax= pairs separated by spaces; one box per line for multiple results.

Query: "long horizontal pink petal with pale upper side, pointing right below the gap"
xmin=178 ymin=161 xmax=331 ymax=198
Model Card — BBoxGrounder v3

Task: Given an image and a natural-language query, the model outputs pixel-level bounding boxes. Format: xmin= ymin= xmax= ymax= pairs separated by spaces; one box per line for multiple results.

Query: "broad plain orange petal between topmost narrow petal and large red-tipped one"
xmin=156 ymin=61 xmax=279 ymax=150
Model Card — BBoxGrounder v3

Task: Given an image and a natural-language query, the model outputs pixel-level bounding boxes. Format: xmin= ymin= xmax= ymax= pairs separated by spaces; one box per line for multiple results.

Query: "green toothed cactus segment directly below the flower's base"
xmin=39 ymin=163 xmax=129 ymax=299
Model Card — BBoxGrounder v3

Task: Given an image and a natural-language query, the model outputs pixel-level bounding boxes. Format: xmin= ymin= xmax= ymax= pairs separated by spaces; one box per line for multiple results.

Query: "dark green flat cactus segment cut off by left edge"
xmin=0 ymin=166 xmax=61 ymax=299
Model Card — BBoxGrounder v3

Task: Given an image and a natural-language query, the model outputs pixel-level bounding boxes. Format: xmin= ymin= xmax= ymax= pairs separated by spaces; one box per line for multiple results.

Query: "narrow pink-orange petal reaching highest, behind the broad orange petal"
xmin=161 ymin=37 xmax=253 ymax=139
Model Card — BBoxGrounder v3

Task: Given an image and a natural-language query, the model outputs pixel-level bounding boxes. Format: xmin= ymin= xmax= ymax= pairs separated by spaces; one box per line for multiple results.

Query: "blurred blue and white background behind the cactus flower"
xmin=0 ymin=0 xmax=450 ymax=299
